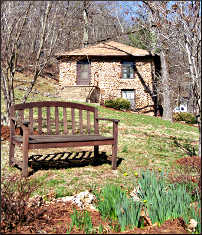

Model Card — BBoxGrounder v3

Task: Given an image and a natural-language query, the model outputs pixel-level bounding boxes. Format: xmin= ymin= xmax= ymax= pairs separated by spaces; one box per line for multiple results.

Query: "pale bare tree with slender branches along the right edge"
xmin=174 ymin=1 xmax=201 ymax=157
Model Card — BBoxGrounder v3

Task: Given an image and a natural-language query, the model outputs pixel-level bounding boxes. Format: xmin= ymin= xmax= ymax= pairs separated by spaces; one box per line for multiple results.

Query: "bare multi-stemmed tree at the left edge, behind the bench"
xmin=1 ymin=2 xmax=31 ymax=119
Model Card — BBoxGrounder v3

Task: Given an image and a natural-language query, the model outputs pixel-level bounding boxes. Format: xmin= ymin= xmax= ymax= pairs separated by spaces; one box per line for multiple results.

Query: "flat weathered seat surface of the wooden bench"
xmin=13 ymin=135 xmax=113 ymax=144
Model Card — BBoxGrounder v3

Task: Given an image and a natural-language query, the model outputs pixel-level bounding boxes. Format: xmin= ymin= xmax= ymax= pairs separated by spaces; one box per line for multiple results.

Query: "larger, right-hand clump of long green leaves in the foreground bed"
xmin=134 ymin=171 xmax=201 ymax=232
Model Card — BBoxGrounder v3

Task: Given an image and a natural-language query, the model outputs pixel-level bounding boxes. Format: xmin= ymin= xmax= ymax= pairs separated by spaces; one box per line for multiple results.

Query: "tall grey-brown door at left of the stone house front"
xmin=77 ymin=60 xmax=90 ymax=85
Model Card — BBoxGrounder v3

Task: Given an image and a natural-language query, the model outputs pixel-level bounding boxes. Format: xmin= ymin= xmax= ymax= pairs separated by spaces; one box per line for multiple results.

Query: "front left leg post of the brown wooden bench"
xmin=22 ymin=125 xmax=29 ymax=177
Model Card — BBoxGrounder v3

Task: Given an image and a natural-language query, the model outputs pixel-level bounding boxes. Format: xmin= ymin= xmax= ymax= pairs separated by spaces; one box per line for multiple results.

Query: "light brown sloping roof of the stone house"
xmin=56 ymin=41 xmax=151 ymax=58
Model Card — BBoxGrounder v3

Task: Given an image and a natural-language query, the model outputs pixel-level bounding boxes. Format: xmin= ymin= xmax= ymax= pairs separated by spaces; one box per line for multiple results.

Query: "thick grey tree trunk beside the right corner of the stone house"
xmin=160 ymin=50 xmax=172 ymax=121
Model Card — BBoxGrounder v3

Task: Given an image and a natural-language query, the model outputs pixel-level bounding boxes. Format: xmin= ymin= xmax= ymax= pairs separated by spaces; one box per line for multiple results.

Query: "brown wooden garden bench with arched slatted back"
xmin=9 ymin=101 xmax=119 ymax=177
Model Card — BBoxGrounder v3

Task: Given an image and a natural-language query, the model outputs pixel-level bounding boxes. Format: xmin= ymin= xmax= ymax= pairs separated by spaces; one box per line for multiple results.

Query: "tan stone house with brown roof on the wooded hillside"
xmin=56 ymin=41 xmax=160 ymax=111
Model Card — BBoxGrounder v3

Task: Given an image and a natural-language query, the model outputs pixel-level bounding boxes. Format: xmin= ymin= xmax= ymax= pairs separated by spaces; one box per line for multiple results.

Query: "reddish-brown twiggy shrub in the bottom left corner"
xmin=1 ymin=175 xmax=38 ymax=232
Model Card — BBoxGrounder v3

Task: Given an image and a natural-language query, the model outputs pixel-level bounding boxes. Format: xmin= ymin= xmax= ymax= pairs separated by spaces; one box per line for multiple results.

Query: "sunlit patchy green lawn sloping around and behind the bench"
xmin=2 ymin=73 xmax=199 ymax=193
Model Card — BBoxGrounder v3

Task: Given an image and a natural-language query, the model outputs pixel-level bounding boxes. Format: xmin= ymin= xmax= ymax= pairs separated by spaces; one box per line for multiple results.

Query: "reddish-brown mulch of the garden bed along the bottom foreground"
xmin=1 ymin=126 xmax=197 ymax=234
